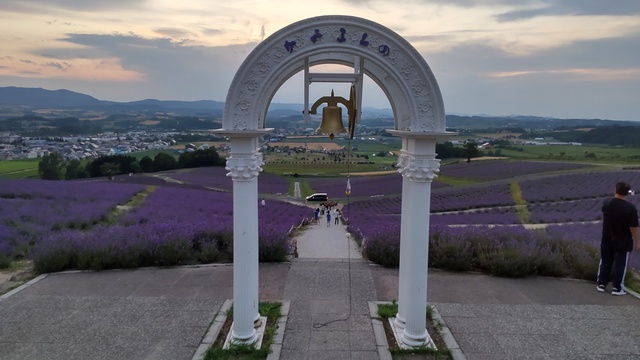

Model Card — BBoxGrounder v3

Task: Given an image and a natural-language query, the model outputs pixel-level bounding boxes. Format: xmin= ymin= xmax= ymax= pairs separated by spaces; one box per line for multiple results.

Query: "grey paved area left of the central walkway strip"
xmin=0 ymin=264 xmax=289 ymax=360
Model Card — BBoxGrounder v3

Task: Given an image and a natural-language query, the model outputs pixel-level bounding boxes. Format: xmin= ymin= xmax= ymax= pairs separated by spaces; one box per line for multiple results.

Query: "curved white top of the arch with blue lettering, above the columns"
xmin=222 ymin=16 xmax=445 ymax=133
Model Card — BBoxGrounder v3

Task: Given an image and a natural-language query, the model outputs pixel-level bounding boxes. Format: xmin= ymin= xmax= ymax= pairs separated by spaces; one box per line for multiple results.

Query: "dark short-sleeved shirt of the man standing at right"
xmin=602 ymin=198 xmax=638 ymax=241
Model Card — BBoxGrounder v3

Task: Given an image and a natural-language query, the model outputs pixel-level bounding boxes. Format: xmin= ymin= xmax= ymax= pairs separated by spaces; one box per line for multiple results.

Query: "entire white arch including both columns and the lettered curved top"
xmin=216 ymin=16 xmax=451 ymax=346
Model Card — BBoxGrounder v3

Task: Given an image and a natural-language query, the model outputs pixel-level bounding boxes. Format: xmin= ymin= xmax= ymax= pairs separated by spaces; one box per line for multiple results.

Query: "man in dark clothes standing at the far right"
xmin=597 ymin=182 xmax=640 ymax=295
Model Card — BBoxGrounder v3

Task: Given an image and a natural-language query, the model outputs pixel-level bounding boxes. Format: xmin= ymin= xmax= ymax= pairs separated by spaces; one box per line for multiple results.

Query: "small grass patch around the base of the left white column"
xmin=204 ymin=302 xmax=282 ymax=360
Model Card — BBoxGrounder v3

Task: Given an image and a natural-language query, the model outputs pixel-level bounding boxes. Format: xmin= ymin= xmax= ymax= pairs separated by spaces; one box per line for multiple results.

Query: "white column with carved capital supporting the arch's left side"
xmin=226 ymin=132 xmax=264 ymax=344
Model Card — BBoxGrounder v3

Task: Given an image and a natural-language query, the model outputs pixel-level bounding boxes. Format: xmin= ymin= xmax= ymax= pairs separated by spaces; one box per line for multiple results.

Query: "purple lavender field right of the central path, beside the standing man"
xmin=344 ymin=165 xmax=640 ymax=280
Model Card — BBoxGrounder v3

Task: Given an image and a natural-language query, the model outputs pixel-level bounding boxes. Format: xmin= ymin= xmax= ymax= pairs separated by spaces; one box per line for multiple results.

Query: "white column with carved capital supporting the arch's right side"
xmin=393 ymin=131 xmax=440 ymax=347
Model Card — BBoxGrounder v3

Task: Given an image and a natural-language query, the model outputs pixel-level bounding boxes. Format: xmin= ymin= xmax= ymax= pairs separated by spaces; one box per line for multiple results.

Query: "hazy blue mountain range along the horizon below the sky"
xmin=0 ymin=86 xmax=640 ymax=129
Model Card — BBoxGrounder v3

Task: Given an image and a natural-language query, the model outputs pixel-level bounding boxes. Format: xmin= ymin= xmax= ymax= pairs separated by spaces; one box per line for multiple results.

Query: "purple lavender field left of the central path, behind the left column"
xmin=0 ymin=180 xmax=310 ymax=272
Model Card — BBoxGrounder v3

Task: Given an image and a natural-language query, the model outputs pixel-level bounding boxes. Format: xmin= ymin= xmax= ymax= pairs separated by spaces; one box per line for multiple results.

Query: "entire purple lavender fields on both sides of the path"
xmin=0 ymin=161 xmax=640 ymax=279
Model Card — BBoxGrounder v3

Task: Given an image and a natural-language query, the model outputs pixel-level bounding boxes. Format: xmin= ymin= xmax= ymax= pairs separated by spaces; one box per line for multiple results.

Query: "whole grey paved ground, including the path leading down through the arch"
xmin=0 ymin=219 xmax=640 ymax=360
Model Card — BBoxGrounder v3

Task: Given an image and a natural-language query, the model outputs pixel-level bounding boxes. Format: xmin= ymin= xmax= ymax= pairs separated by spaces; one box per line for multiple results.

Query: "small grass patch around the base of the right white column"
xmin=378 ymin=301 xmax=453 ymax=360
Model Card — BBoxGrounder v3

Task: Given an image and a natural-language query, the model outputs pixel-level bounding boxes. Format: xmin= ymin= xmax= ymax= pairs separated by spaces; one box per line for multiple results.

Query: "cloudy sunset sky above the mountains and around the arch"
xmin=0 ymin=0 xmax=640 ymax=121
